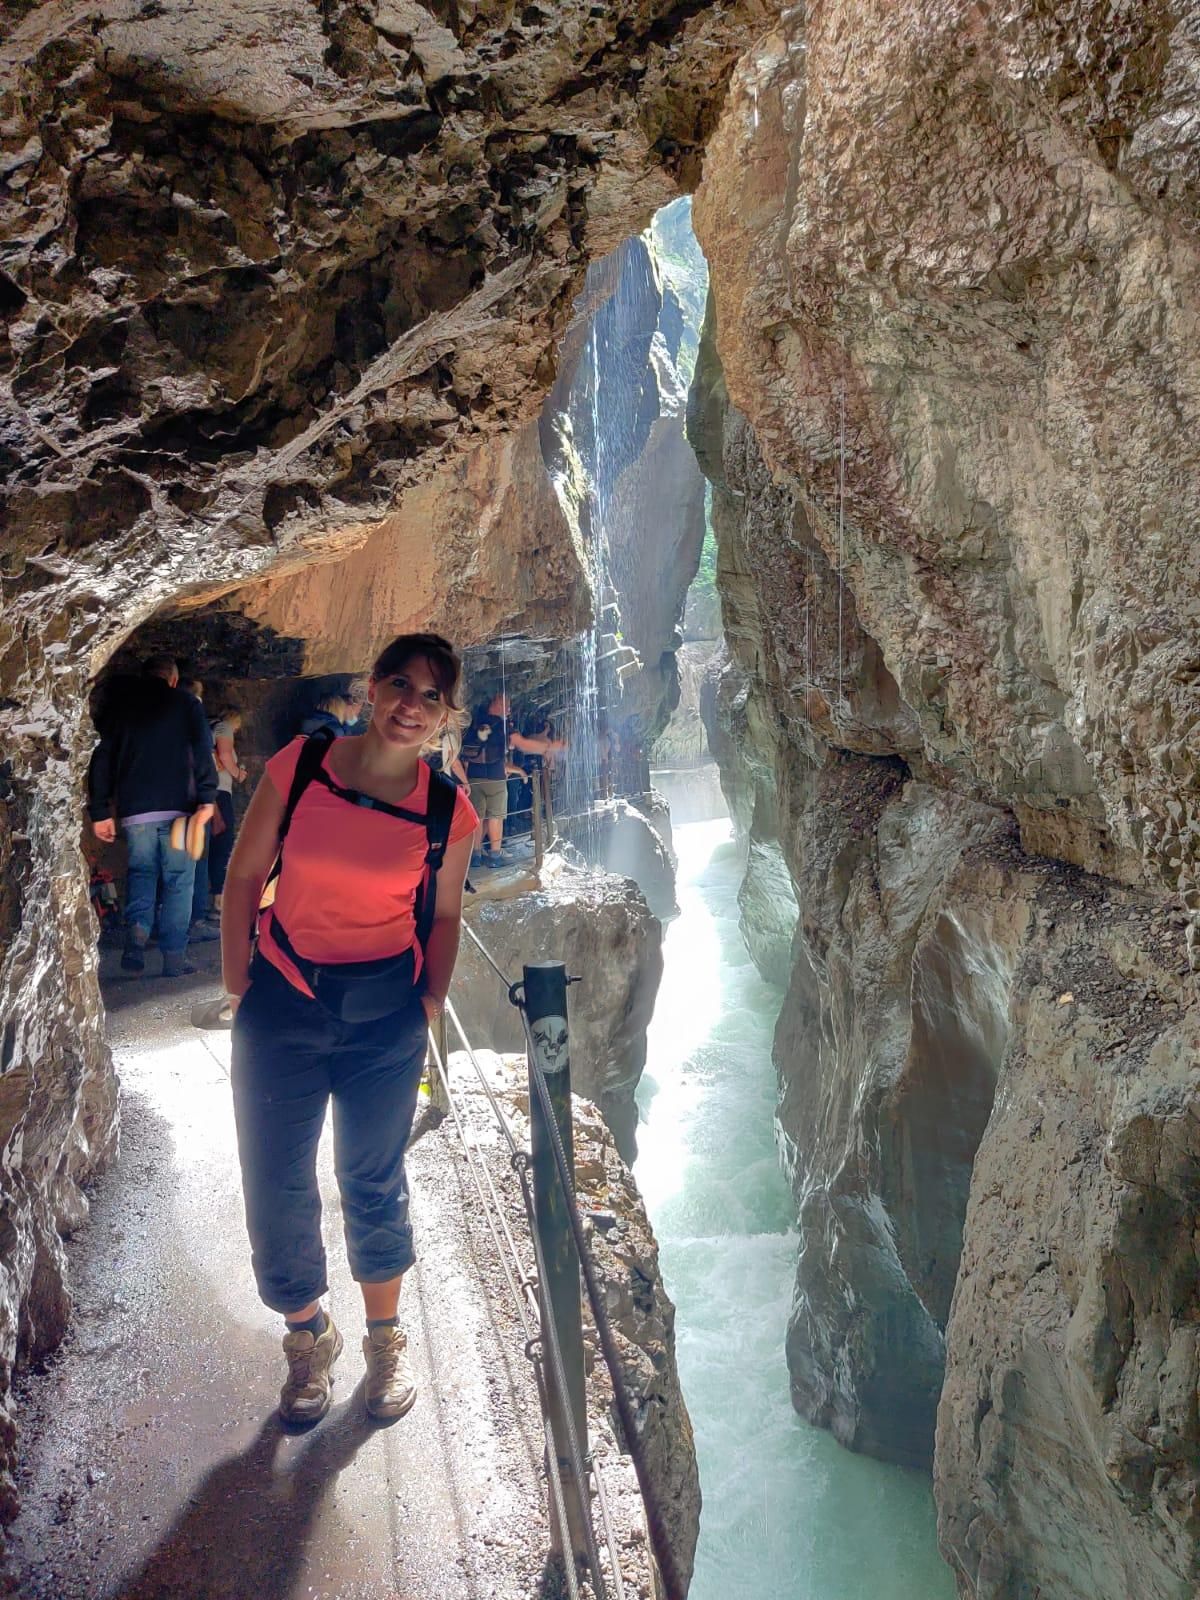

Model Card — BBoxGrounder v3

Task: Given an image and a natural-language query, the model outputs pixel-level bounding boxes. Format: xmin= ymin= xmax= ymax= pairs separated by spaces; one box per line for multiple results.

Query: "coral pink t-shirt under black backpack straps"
xmin=258 ymin=738 xmax=478 ymax=995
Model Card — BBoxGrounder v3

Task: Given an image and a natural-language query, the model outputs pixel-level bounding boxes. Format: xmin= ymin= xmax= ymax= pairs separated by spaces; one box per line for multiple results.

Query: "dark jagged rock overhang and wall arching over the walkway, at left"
xmin=0 ymin=0 xmax=766 ymax=1510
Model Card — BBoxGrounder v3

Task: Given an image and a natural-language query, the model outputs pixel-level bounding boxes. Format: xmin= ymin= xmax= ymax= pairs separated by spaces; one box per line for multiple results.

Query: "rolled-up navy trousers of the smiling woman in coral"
xmin=232 ymin=955 xmax=429 ymax=1317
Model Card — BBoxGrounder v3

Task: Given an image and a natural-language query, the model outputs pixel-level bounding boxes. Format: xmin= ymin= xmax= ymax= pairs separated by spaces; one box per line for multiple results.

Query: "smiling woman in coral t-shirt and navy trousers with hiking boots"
xmin=221 ymin=634 xmax=475 ymax=1422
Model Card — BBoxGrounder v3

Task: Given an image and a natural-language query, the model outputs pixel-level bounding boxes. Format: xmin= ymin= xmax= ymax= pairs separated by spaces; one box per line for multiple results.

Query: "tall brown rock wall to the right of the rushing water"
xmin=690 ymin=0 xmax=1200 ymax=1600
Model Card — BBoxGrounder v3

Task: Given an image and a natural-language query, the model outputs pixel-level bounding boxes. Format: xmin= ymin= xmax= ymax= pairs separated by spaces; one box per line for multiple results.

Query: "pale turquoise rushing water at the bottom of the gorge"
xmin=635 ymin=800 xmax=954 ymax=1600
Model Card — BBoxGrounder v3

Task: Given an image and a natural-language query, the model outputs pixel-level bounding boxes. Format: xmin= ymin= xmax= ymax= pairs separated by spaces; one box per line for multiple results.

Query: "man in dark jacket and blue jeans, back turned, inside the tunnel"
xmin=88 ymin=656 xmax=216 ymax=978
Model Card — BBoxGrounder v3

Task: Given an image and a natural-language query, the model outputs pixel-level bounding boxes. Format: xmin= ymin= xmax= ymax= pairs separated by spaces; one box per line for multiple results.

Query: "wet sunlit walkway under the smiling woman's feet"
xmin=11 ymin=978 xmax=557 ymax=1600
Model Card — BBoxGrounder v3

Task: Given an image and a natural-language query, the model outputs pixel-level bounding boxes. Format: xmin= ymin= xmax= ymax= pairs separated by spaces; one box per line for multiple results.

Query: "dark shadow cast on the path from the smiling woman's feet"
xmin=113 ymin=1384 xmax=377 ymax=1600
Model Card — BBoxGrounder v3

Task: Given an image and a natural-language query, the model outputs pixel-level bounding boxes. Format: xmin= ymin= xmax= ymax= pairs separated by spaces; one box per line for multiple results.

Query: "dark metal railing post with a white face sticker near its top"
xmin=525 ymin=962 xmax=587 ymax=1560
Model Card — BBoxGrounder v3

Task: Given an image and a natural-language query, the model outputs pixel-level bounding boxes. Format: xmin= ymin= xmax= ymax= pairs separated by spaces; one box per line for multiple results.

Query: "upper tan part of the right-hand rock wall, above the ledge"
xmin=696 ymin=0 xmax=1200 ymax=915
